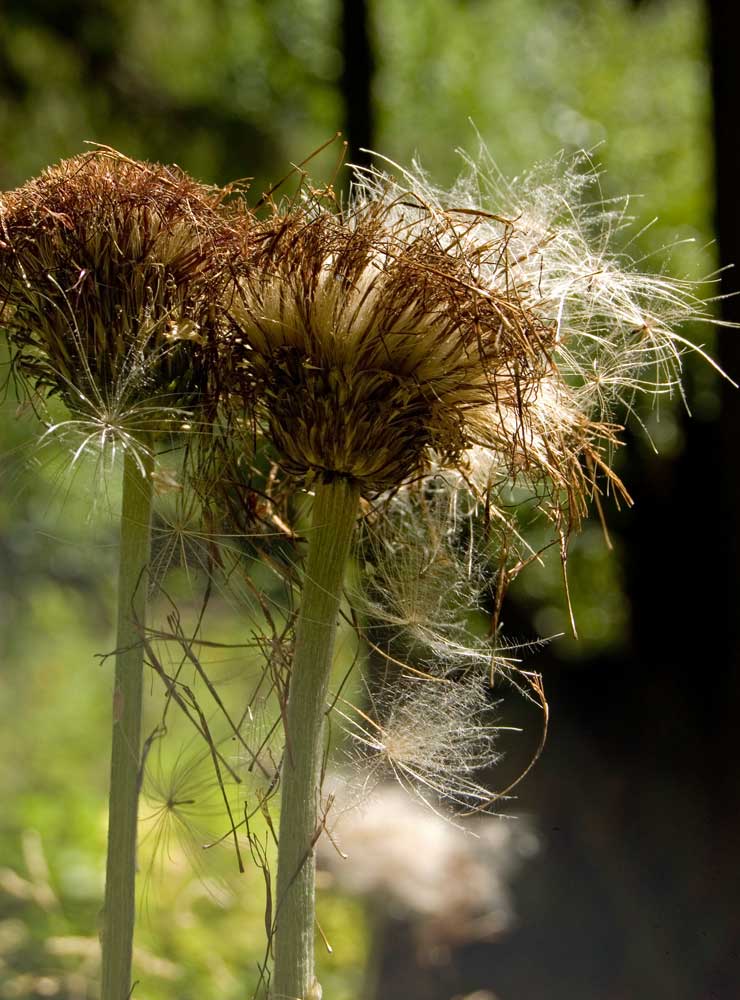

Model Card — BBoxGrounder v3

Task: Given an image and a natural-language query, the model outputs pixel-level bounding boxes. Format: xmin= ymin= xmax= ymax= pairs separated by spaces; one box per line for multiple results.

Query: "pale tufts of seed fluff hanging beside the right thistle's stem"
xmin=339 ymin=476 xmax=547 ymax=816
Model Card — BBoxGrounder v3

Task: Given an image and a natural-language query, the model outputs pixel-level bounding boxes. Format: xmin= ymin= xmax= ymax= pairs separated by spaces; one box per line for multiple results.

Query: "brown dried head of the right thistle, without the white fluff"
xmin=227 ymin=190 xmax=555 ymax=493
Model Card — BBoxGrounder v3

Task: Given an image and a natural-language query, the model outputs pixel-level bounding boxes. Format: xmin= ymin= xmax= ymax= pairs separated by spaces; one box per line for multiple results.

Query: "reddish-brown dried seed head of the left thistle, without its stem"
xmin=0 ymin=148 xmax=237 ymax=472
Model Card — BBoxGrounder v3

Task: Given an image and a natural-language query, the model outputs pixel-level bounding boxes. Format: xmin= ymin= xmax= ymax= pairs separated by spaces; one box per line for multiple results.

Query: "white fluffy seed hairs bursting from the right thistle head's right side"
xmin=348 ymin=153 xmax=728 ymax=541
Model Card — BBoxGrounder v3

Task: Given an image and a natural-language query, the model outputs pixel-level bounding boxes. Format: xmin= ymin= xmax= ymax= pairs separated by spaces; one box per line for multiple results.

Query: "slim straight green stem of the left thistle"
xmin=101 ymin=442 xmax=153 ymax=1000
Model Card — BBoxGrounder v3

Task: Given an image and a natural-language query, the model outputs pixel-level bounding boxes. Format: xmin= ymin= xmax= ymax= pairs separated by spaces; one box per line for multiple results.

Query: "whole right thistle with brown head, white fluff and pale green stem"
xmin=214 ymin=148 xmax=716 ymax=1000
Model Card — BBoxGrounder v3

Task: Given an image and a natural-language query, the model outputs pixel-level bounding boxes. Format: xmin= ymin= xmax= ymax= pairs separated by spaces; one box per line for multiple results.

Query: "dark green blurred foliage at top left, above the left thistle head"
xmin=0 ymin=0 xmax=341 ymax=193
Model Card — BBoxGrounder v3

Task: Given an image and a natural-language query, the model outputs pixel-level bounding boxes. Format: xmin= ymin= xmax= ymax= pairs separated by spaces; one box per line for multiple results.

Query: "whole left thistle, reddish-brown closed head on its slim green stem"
xmin=0 ymin=149 xmax=236 ymax=1000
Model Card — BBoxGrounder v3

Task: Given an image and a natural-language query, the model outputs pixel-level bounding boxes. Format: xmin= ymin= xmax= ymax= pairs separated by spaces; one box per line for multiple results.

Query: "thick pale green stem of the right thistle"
xmin=272 ymin=479 xmax=359 ymax=1000
